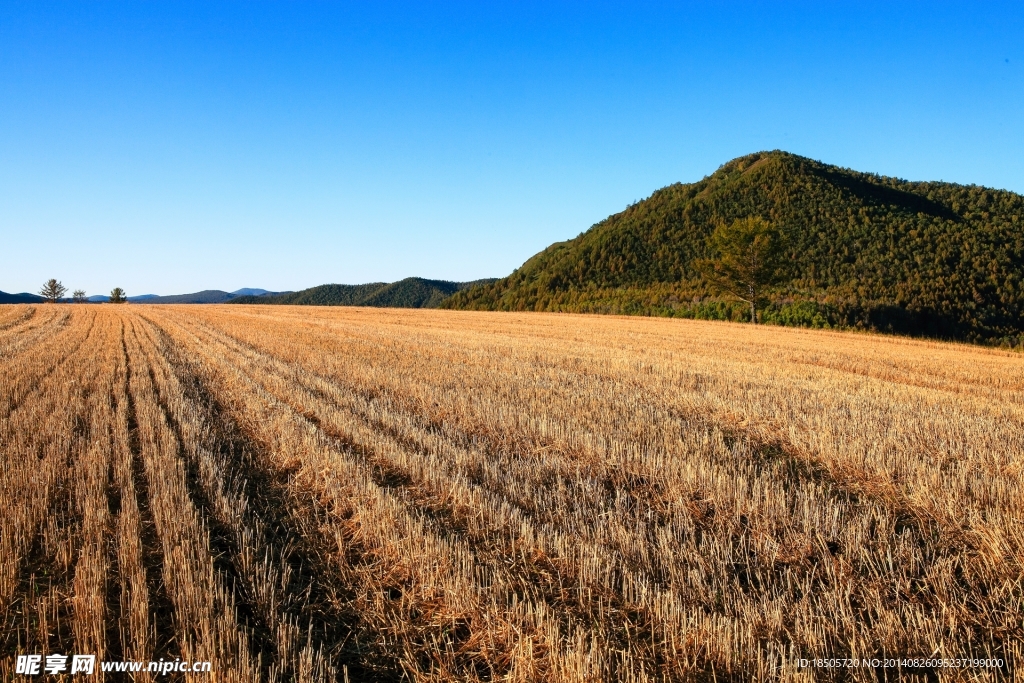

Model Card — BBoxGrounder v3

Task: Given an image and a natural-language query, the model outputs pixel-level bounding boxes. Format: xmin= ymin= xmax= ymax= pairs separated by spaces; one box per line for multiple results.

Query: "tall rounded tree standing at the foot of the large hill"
xmin=698 ymin=216 xmax=787 ymax=325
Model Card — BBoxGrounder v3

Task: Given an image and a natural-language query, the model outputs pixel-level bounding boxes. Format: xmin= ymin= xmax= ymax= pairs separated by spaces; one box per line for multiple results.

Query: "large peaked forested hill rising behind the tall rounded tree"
xmin=442 ymin=152 xmax=1024 ymax=345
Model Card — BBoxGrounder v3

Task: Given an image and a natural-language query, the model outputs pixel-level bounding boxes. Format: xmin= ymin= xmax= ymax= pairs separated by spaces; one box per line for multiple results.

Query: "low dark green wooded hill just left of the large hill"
xmin=228 ymin=278 xmax=494 ymax=308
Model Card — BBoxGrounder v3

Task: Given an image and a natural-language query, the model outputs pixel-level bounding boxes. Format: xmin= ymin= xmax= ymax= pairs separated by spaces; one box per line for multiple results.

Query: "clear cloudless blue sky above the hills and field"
xmin=0 ymin=0 xmax=1024 ymax=295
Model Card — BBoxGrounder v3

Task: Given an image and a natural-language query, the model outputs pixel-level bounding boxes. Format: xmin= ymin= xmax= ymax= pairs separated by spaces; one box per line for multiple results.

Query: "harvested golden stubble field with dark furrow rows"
xmin=0 ymin=305 xmax=1024 ymax=681
